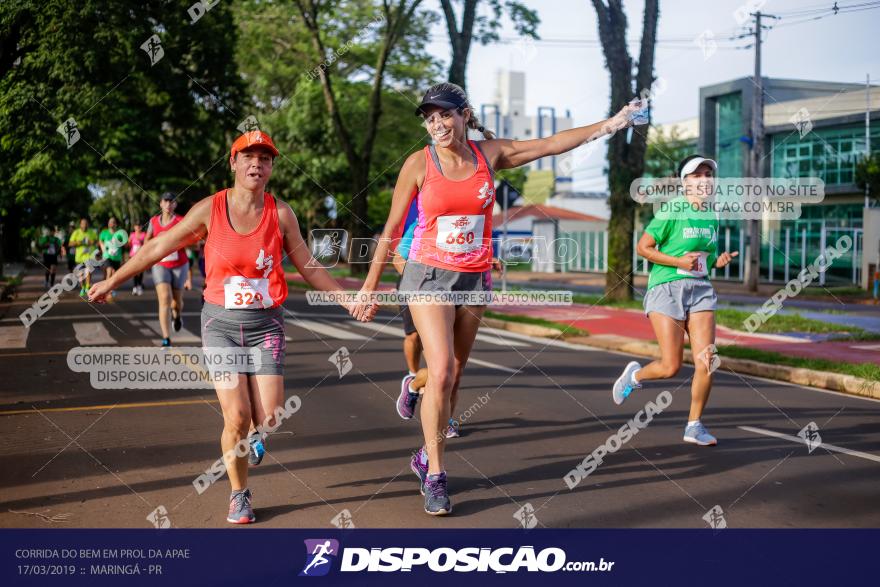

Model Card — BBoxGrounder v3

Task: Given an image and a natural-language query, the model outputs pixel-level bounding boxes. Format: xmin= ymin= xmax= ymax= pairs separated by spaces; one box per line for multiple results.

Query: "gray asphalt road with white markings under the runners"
xmin=0 ymin=275 xmax=880 ymax=528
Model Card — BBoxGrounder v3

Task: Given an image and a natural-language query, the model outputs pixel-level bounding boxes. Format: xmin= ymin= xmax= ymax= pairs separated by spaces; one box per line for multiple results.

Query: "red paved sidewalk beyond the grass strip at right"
xmin=286 ymin=273 xmax=880 ymax=364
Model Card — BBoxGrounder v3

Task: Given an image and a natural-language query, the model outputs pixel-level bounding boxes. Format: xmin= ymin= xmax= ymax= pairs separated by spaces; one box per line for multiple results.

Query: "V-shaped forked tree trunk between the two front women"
xmin=295 ymin=0 xmax=434 ymax=273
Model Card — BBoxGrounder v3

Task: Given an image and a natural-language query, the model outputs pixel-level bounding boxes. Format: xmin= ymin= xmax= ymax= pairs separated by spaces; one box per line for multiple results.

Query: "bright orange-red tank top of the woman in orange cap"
xmin=205 ymin=190 xmax=287 ymax=310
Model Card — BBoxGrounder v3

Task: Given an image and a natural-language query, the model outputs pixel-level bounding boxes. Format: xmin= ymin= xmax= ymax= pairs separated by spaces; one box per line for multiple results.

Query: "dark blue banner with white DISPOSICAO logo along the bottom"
xmin=0 ymin=528 xmax=880 ymax=587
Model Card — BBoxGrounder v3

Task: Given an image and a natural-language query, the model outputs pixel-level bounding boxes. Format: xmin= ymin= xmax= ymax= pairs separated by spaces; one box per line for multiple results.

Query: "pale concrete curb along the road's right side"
xmin=483 ymin=318 xmax=880 ymax=399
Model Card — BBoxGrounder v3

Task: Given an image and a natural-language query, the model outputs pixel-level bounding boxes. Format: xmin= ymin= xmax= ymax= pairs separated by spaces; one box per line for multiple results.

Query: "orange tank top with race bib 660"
xmin=409 ymin=141 xmax=495 ymax=273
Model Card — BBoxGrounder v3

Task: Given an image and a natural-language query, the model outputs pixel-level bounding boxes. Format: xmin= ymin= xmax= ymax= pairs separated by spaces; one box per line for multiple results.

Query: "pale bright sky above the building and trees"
xmin=425 ymin=0 xmax=880 ymax=190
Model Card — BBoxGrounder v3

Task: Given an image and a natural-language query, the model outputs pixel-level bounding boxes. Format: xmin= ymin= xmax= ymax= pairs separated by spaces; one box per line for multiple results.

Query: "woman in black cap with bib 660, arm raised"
xmin=355 ymin=83 xmax=639 ymax=515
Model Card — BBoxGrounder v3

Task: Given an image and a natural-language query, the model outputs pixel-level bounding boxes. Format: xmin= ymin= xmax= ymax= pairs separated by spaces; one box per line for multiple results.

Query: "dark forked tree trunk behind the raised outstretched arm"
xmin=591 ymin=0 xmax=659 ymax=300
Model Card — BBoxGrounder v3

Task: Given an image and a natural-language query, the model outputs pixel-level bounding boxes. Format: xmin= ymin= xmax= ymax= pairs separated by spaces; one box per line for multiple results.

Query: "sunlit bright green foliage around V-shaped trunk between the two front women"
xmin=234 ymin=0 xmax=441 ymax=243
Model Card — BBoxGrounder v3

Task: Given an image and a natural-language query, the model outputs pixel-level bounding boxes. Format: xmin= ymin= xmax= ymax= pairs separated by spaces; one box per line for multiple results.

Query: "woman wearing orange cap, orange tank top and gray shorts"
xmin=89 ymin=131 xmax=364 ymax=524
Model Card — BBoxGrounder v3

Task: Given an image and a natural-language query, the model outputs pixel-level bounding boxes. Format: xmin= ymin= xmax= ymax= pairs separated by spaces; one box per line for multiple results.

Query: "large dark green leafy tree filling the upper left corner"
xmin=0 ymin=0 xmax=243 ymax=266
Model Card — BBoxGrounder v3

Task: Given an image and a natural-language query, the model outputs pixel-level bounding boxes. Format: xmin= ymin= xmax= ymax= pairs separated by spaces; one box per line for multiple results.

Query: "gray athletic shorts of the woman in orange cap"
xmin=202 ymin=302 xmax=287 ymax=375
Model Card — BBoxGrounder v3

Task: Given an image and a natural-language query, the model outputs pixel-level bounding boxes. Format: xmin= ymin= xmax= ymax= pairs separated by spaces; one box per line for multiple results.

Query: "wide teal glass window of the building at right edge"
xmin=771 ymin=124 xmax=880 ymax=185
